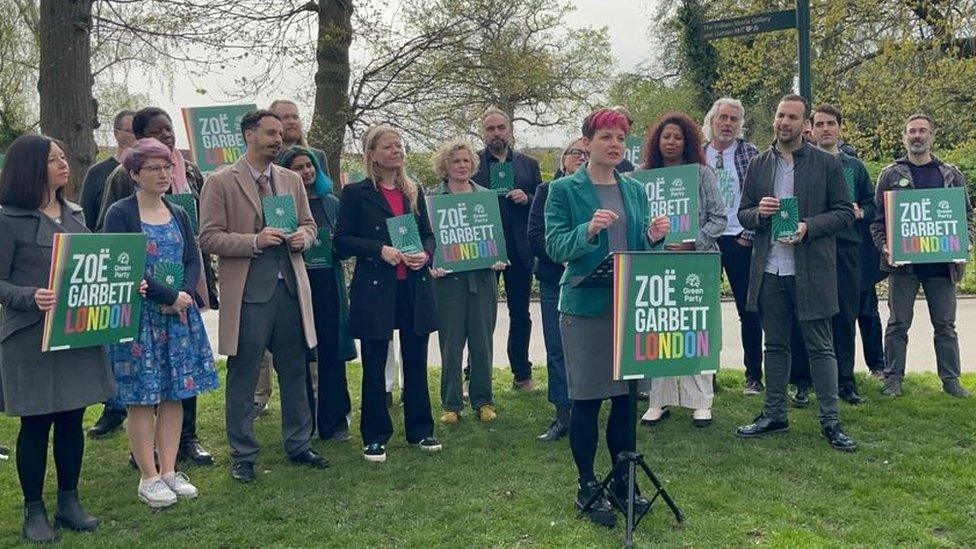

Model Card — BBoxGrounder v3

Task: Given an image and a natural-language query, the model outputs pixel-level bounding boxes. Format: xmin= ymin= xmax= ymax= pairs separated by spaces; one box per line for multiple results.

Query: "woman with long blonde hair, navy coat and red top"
xmin=333 ymin=125 xmax=441 ymax=462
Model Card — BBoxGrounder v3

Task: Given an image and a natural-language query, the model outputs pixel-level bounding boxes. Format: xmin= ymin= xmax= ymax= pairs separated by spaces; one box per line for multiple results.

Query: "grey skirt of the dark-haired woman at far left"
xmin=0 ymin=322 xmax=115 ymax=416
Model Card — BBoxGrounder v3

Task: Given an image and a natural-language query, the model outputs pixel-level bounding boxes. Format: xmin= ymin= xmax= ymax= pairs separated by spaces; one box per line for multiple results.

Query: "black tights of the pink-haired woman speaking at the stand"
xmin=569 ymin=395 xmax=633 ymax=482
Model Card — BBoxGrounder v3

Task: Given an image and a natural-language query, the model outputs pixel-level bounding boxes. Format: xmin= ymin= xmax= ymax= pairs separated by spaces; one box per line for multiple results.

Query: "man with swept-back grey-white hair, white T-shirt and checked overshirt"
xmin=702 ymin=97 xmax=763 ymax=395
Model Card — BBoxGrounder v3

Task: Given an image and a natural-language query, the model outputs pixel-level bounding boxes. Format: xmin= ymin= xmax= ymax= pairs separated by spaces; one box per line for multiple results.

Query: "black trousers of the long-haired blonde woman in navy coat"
xmin=360 ymin=280 xmax=434 ymax=445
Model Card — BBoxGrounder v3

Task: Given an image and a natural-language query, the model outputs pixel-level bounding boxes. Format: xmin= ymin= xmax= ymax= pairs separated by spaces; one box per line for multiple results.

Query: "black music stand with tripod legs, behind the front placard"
xmin=570 ymin=254 xmax=685 ymax=547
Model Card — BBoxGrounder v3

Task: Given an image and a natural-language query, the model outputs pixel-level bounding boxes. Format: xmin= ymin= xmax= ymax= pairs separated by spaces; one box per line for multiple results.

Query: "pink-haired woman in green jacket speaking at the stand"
xmin=545 ymin=109 xmax=669 ymax=526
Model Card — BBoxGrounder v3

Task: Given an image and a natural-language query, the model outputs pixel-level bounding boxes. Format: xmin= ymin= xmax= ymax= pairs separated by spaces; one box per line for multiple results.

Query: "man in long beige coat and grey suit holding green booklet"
xmin=200 ymin=110 xmax=328 ymax=482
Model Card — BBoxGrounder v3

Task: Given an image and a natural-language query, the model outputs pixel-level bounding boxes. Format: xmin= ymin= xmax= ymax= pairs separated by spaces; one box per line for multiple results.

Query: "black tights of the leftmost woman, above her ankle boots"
xmin=17 ymin=408 xmax=85 ymax=503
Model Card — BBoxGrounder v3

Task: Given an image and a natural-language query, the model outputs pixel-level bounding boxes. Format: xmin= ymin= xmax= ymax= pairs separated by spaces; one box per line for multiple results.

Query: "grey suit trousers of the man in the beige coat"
xmin=225 ymin=280 xmax=312 ymax=463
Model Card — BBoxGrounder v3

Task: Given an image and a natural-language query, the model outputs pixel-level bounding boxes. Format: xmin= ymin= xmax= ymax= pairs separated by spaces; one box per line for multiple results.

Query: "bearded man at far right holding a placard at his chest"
xmin=871 ymin=114 xmax=976 ymax=398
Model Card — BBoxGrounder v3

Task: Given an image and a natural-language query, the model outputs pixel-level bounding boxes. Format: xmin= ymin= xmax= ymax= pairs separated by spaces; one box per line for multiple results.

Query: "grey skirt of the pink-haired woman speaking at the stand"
xmin=559 ymin=307 xmax=627 ymax=400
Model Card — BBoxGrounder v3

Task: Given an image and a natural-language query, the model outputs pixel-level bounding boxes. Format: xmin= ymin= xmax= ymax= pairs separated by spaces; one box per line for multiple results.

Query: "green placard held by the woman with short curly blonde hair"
xmin=427 ymin=192 xmax=508 ymax=272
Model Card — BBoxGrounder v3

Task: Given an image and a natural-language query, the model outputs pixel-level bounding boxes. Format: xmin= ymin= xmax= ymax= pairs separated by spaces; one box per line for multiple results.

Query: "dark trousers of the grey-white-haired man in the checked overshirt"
xmin=718 ymin=235 xmax=763 ymax=381
